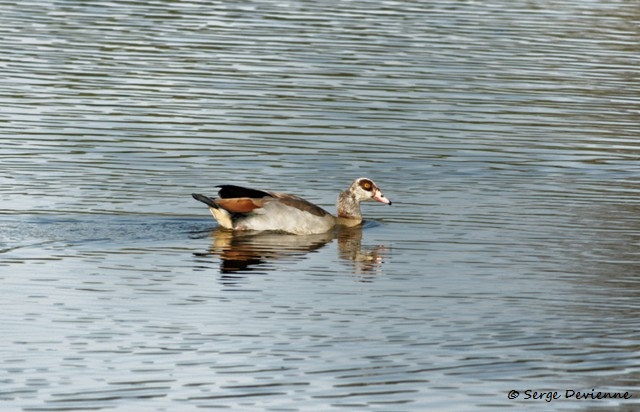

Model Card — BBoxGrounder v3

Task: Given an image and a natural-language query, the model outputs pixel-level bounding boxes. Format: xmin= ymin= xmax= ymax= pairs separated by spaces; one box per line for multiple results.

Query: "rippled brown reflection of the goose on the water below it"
xmin=196 ymin=227 xmax=386 ymax=281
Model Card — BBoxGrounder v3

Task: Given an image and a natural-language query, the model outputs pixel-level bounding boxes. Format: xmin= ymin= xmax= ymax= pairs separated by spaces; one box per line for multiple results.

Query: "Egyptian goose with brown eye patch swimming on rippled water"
xmin=192 ymin=177 xmax=391 ymax=235
